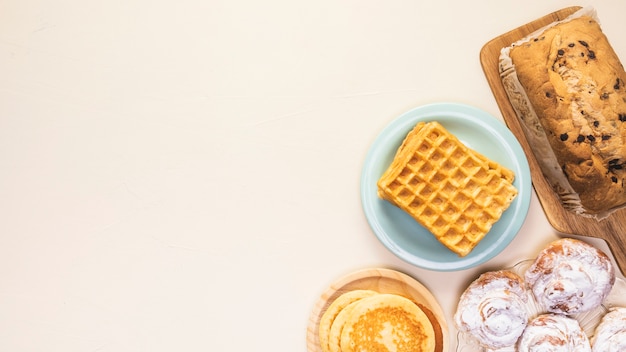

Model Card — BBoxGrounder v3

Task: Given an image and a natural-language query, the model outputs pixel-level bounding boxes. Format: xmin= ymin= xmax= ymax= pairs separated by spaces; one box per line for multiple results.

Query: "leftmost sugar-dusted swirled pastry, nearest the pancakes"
xmin=454 ymin=270 xmax=529 ymax=349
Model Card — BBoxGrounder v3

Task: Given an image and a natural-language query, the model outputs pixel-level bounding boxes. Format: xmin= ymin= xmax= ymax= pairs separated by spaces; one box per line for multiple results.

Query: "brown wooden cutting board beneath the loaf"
xmin=480 ymin=6 xmax=626 ymax=274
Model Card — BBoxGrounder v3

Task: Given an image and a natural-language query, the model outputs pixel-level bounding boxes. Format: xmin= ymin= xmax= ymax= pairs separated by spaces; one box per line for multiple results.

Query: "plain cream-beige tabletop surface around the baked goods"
xmin=0 ymin=0 xmax=626 ymax=352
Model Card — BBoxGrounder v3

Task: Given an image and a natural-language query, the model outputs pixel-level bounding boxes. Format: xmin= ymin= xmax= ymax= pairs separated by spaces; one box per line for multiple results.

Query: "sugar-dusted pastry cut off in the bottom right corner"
xmin=591 ymin=307 xmax=626 ymax=352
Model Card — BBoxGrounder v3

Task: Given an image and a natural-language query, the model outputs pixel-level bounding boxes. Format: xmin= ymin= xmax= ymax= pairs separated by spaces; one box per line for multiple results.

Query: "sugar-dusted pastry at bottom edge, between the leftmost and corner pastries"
xmin=517 ymin=313 xmax=591 ymax=352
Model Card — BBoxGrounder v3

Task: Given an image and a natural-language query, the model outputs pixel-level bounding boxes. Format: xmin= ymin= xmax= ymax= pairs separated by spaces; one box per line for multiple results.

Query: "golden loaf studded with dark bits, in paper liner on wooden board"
xmin=500 ymin=8 xmax=626 ymax=219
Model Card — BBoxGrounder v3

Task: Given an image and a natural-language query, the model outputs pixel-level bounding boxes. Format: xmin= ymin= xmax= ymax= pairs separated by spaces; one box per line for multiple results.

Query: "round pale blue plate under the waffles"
xmin=361 ymin=103 xmax=532 ymax=271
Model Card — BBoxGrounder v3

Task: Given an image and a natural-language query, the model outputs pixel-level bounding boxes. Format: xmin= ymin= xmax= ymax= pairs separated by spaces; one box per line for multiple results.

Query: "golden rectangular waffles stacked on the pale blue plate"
xmin=378 ymin=121 xmax=517 ymax=257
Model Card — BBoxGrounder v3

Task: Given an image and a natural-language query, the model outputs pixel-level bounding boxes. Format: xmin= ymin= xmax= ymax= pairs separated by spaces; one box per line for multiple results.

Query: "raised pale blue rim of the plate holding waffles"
xmin=360 ymin=102 xmax=532 ymax=272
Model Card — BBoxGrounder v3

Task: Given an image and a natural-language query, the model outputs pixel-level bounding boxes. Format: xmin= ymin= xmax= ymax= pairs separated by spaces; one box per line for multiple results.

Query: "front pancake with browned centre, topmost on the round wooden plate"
xmin=333 ymin=294 xmax=435 ymax=352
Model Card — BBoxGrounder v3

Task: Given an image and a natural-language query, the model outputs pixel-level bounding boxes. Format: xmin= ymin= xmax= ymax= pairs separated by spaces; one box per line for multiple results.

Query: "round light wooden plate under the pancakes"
xmin=307 ymin=268 xmax=449 ymax=352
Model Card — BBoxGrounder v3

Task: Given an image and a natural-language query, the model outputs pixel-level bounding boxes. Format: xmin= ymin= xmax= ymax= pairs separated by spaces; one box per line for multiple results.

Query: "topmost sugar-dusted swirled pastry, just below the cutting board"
xmin=525 ymin=238 xmax=615 ymax=314
